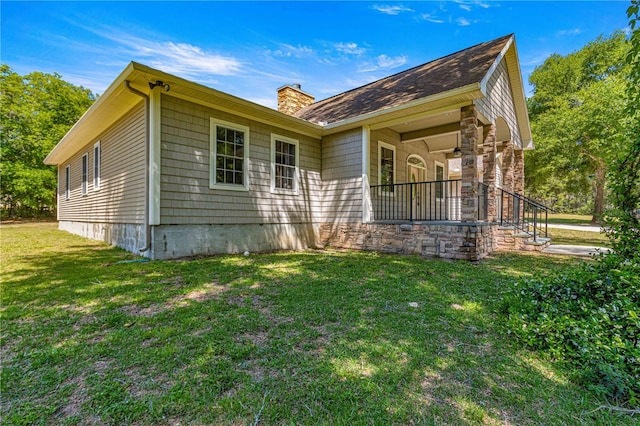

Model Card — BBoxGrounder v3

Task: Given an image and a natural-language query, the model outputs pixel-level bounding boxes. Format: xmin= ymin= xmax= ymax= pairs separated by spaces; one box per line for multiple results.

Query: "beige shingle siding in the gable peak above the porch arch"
xmin=475 ymin=59 xmax=522 ymax=147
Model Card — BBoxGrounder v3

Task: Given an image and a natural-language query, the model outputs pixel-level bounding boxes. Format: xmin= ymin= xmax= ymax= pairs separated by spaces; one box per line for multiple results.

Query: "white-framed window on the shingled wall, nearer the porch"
xmin=271 ymin=134 xmax=299 ymax=194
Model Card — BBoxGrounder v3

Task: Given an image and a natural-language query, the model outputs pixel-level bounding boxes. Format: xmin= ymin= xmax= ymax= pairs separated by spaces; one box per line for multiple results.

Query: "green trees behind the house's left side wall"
xmin=0 ymin=65 xmax=96 ymax=216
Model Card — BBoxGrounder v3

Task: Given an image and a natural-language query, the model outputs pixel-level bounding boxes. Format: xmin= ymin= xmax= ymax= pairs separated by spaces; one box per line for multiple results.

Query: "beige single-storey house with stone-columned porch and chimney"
xmin=45 ymin=35 xmax=548 ymax=260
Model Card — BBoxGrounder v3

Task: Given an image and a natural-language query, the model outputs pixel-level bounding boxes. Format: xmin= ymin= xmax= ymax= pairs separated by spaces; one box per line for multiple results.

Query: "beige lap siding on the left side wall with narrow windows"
xmin=58 ymin=102 xmax=145 ymax=223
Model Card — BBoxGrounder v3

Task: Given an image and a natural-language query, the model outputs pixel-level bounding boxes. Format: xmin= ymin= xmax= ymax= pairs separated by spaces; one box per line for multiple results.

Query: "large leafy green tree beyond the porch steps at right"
xmin=526 ymin=32 xmax=629 ymax=222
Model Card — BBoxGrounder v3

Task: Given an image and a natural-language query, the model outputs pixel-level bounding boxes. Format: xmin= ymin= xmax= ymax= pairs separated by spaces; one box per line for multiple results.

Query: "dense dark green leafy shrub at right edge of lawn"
xmin=503 ymin=253 xmax=640 ymax=406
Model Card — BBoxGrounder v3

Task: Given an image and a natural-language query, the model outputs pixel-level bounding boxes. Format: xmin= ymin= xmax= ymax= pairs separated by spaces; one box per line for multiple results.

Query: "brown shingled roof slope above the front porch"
xmin=294 ymin=34 xmax=513 ymax=124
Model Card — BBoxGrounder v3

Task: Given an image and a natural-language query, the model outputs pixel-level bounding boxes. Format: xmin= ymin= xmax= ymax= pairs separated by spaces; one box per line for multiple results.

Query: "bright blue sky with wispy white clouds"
xmin=0 ymin=0 xmax=629 ymax=107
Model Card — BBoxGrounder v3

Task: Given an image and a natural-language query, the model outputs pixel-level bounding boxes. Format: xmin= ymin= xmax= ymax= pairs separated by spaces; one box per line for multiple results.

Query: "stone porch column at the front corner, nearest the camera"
xmin=460 ymin=105 xmax=478 ymax=222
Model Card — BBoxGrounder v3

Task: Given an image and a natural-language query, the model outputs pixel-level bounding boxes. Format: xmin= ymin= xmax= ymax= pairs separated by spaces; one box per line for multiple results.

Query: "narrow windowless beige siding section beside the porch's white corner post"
xmin=322 ymin=128 xmax=362 ymax=222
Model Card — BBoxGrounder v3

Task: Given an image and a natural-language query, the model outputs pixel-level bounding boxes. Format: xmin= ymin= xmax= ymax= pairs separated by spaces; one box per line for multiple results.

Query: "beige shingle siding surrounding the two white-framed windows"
xmin=160 ymin=94 xmax=322 ymax=225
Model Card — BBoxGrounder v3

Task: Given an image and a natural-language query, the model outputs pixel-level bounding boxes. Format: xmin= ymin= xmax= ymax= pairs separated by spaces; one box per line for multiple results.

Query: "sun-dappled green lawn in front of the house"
xmin=0 ymin=224 xmax=634 ymax=425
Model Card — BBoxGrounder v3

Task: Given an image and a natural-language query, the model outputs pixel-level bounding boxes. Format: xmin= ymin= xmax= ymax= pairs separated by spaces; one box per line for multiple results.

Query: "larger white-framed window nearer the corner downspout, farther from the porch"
xmin=209 ymin=118 xmax=249 ymax=191
